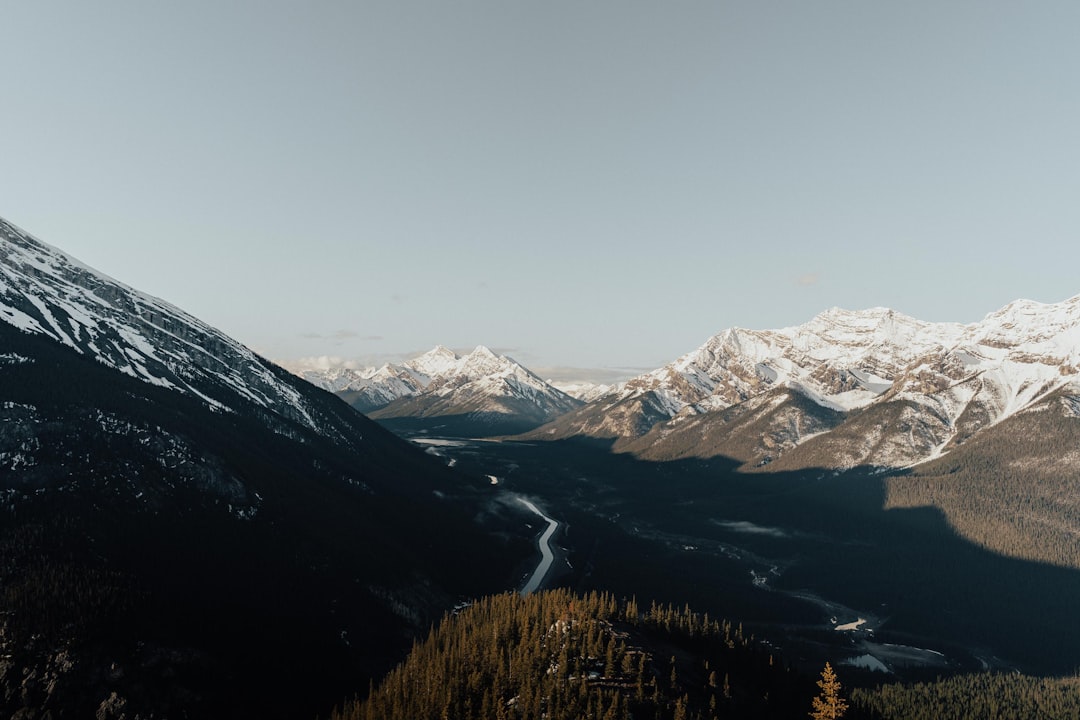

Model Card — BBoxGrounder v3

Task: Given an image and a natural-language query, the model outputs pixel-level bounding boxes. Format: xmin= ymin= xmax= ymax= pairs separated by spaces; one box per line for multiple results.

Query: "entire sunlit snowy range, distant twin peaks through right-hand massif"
xmin=305 ymin=296 xmax=1080 ymax=470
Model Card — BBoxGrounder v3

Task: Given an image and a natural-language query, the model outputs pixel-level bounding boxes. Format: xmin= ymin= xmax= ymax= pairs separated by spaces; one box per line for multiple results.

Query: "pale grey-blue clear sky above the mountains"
xmin=0 ymin=0 xmax=1080 ymax=380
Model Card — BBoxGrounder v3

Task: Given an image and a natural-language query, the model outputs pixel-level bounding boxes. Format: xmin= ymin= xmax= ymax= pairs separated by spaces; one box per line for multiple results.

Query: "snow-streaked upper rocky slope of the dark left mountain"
xmin=0 ymin=219 xmax=321 ymax=431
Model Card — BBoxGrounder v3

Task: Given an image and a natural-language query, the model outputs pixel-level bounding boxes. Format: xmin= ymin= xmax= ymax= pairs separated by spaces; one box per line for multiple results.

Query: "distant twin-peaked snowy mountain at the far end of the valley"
xmin=302 ymin=345 xmax=581 ymax=435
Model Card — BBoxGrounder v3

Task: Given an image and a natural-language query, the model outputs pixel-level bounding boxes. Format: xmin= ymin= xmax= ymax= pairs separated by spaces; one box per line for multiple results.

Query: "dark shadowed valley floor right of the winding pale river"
xmin=397 ymin=431 xmax=1080 ymax=684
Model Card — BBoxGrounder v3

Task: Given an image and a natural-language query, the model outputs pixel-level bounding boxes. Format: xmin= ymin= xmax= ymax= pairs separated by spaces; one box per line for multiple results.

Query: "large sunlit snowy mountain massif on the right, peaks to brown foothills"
xmin=532 ymin=296 xmax=1080 ymax=466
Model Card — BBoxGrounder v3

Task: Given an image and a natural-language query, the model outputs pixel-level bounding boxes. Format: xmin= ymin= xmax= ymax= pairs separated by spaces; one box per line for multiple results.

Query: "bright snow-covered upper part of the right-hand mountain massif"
xmin=604 ymin=296 xmax=1080 ymax=416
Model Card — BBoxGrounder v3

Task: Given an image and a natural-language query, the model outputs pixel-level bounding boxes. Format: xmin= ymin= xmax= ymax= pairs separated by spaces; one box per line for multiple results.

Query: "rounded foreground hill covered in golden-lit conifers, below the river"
xmin=333 ymin=590 xmax=862 ymax=720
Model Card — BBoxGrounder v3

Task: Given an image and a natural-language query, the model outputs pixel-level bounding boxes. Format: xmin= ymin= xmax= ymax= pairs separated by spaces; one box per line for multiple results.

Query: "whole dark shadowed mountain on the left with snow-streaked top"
xmin=0 ymin=215 xmax=529 ymax=718
